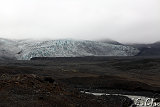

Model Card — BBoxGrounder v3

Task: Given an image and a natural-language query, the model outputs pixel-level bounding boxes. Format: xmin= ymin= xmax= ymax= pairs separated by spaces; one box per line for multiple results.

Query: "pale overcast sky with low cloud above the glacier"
xmin=0 ymin=0 xmax=160 ymax=42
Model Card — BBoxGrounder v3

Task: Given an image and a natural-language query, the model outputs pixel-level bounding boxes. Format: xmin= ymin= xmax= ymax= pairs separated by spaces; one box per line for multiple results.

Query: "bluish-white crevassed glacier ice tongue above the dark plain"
xmin=0 ymin=39 xmax=139 ymax=60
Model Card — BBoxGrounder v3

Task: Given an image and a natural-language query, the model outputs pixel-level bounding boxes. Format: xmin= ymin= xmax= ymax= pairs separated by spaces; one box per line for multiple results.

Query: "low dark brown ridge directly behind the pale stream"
xmin=62 ymin=76 xmax=159 ymax=92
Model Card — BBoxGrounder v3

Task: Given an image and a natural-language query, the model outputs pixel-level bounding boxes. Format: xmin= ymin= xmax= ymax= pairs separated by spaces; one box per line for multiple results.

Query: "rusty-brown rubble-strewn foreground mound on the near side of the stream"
xmin=0 ymin=74 xmax=130 ymax=107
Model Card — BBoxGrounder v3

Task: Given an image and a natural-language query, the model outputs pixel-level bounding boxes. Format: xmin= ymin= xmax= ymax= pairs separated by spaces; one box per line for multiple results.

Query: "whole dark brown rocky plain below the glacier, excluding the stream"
xmin=0 ymin=57 xmax=160 ymax=107
